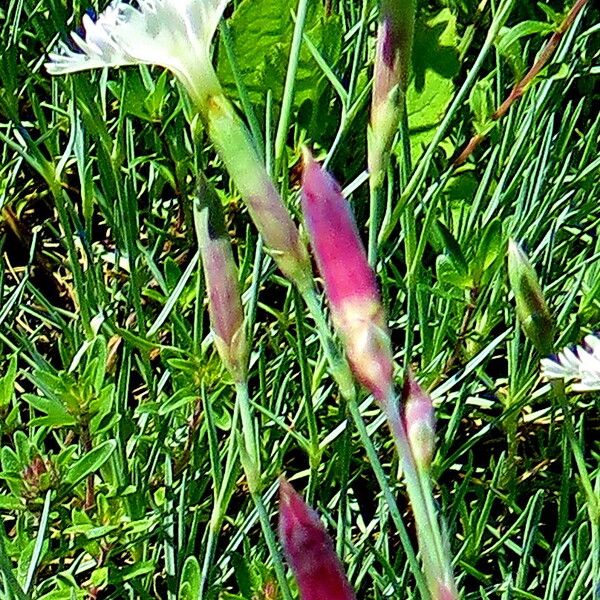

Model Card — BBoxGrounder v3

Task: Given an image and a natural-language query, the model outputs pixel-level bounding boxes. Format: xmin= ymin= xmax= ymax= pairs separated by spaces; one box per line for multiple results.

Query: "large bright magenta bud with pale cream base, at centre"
xmin=302 ymin=150 xmax=392 ymax=400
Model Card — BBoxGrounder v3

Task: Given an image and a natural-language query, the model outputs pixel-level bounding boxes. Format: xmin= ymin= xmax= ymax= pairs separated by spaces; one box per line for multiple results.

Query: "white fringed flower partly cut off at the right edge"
xmin=542 ymin=335 xmax=600 ymax=392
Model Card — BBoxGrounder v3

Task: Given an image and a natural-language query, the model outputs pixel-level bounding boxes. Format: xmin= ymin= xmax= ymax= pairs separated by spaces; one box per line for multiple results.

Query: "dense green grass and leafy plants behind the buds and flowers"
xmin=0 ymin=0 xmax=600 ymax=600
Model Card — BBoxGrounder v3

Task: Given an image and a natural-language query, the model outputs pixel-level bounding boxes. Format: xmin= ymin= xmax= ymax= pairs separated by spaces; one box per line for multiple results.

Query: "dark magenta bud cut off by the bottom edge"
xmin=279 ymin=478 xmax=355 ymax=600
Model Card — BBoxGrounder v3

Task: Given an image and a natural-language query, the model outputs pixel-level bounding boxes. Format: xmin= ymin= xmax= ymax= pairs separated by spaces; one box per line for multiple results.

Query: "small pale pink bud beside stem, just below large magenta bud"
xmin=402 ymin=371 xmax=435 ymax=469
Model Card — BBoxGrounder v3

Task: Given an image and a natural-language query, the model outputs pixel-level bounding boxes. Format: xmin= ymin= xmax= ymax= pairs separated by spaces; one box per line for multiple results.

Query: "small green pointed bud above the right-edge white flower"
xmin=508 ymin=240 xmax=554 ymax=355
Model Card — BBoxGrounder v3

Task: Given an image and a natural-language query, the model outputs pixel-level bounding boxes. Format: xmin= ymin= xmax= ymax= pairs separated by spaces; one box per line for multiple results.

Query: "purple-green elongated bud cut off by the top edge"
xmin=369 ymin=0 xmax=416 ymax=178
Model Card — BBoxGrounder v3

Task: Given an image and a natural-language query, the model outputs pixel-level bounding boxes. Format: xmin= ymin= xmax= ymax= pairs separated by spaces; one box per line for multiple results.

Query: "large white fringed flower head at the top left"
xmin=46 ymin=0 xmax=229 ymax=105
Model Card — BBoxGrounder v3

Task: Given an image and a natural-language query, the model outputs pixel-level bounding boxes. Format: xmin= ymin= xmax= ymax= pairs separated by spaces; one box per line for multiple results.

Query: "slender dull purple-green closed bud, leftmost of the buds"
xmin=195 ymin=176 xmax=248 ymax=381
